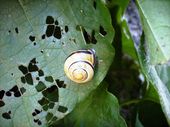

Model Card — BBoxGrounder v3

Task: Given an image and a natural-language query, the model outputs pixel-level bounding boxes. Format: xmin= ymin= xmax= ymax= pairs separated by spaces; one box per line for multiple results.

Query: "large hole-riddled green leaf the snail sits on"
xmin=0 ymin=0 xmax=114 ymax=127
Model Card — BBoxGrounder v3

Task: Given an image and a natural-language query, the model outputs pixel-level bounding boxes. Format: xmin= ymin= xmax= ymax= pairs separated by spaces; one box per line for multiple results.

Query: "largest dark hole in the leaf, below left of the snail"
xmin=42 ymin=85 xmax=59 ymax=102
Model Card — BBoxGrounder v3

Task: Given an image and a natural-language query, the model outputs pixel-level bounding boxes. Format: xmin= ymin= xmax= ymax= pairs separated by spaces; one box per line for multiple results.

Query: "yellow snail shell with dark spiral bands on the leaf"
xmin=64 ymin=49 xmax=96 ymax=83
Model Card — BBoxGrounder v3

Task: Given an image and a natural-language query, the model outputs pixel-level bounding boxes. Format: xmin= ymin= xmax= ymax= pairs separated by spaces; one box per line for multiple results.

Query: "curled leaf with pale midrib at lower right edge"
xmin=138 ymin=33 xmax=170 ymax=125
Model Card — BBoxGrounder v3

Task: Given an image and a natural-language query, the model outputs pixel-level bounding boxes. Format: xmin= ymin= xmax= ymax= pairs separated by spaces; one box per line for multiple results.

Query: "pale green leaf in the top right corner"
xmin=137 ymin=0 xmax=170 ymax=65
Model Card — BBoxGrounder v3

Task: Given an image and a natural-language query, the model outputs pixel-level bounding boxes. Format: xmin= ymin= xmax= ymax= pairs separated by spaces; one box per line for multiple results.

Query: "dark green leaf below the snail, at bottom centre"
xmin=60 ymin=83 xmax=126 ymax=127
